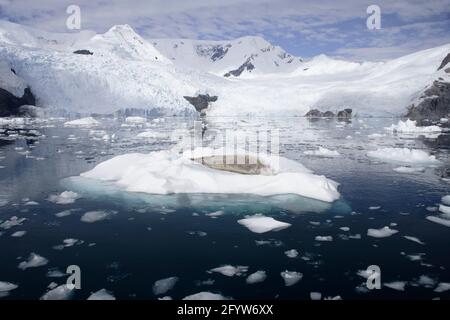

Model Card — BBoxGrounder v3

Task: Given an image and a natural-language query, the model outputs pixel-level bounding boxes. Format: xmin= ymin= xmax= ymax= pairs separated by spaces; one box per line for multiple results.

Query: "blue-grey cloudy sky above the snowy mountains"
xmin=0 ymin=0 xmax=450 ymax=61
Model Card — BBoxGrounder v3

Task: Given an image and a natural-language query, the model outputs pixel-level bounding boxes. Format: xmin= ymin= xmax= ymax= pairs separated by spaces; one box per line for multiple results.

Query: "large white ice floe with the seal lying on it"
xmin=81 ymin=148 xmax=340 ymax=202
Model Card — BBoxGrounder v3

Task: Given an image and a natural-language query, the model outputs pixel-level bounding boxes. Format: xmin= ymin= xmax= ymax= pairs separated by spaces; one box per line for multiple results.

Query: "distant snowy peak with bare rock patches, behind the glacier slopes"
xmin=151 ymin=36 xmax=302 ymax=77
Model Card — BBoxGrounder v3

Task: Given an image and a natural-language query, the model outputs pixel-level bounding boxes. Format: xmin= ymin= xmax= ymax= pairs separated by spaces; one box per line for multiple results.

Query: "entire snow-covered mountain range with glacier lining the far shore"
xmin=0 ymin=21 xmax=450 ymax=117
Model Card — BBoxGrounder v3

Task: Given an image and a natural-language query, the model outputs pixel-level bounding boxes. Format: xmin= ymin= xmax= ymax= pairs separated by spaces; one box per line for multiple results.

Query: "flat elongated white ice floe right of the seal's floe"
xmin=367 ymin=148 xmax=439 ymax=165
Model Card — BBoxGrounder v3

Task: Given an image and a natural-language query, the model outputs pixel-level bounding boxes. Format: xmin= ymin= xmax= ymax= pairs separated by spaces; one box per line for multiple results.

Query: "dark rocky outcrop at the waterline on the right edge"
xmin=406 ymin=81 xmax=450 ymax=124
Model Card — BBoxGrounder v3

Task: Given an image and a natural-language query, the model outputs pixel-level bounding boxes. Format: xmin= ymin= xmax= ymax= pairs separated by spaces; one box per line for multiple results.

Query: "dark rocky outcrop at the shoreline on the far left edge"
xmin=0 ymin=88 xmax=36 ymax=117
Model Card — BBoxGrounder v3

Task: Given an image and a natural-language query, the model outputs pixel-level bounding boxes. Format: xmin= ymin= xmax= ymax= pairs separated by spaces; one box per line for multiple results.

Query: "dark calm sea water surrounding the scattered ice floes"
xmin=0 ymin=118 xmax=450 ymax=299
